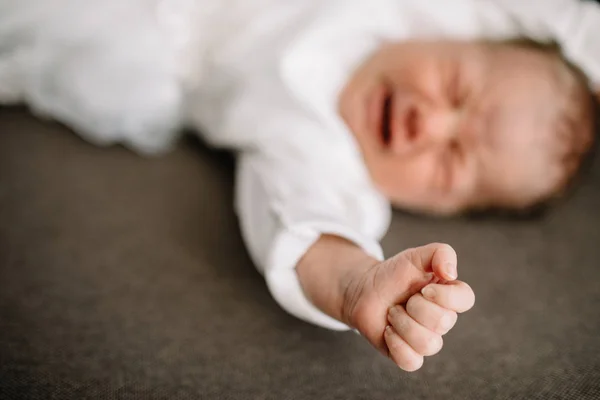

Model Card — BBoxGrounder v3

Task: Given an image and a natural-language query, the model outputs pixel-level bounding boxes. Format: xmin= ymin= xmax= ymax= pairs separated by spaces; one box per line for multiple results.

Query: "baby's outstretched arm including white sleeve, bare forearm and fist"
xmin=236 ymin=148 xmax=474 ymax=371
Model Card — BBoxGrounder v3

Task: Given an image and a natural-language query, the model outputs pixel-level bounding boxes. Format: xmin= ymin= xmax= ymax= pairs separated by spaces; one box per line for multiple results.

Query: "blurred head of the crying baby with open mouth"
xmin=340 ymin=41 xmax=594 ymax=214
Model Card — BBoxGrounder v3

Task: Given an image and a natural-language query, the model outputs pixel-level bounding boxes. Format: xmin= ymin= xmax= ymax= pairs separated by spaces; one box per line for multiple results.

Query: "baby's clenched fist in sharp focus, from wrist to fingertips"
xmin=344 ymin=243 xmax=475 ymax=371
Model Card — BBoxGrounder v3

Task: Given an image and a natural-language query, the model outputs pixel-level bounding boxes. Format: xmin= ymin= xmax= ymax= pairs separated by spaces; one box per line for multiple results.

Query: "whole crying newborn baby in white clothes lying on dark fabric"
xmin=0 ymin=0 xmax=600 ymax=371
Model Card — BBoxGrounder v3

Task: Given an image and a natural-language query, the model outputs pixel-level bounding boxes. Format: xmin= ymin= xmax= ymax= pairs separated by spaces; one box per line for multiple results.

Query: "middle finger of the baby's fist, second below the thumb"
xmin=406 ymin=293 xmax=458 ymax=335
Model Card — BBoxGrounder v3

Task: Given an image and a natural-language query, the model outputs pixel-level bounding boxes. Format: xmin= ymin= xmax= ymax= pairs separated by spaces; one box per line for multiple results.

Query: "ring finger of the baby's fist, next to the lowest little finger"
xmin=388 ymin=306 xmax=444 ymax=356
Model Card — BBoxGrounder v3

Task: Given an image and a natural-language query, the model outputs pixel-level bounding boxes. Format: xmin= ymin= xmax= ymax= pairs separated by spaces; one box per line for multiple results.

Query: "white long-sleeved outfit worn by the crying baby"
xmin=0 ymin=0 xmax=600 ymax=329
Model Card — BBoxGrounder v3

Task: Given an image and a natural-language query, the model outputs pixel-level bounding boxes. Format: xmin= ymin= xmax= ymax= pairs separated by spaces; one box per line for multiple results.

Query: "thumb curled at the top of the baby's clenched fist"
xmin=413 ymin=243 xmax=458 ymax=281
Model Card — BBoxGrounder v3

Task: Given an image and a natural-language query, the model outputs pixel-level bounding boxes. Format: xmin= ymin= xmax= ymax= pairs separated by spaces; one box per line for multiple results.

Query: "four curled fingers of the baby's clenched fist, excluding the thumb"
xmin=384 ymin=281 xmax=475 ymax=371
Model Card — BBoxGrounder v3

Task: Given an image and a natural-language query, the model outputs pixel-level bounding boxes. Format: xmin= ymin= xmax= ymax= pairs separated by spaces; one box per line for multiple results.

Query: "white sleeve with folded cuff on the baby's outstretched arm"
xmin=236 ymin=148 xmax=389 ymax=330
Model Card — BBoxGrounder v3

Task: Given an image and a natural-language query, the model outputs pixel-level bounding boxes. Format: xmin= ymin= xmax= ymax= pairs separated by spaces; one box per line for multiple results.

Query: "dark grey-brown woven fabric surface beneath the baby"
xmin=0 ymin=109 xmax=600 ymax=400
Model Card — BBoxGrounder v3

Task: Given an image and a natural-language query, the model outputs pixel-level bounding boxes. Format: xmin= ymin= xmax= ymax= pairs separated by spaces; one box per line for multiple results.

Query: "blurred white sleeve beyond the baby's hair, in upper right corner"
xmin=493 ymin=0 xmax=600 ymax=88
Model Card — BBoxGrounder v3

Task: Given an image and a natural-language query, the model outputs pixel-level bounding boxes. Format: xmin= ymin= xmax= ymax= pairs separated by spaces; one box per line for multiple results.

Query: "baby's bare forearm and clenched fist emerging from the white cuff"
xmin=296 ymin=235 xmax=475 ymax=371
